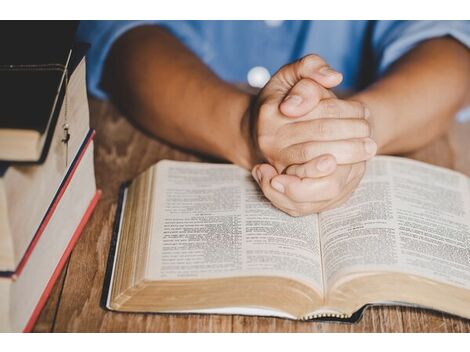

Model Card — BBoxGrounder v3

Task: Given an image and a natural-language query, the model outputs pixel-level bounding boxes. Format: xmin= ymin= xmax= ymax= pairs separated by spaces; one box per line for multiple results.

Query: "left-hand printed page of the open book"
xmin=146 ymin=161 xmax=322 ymax=293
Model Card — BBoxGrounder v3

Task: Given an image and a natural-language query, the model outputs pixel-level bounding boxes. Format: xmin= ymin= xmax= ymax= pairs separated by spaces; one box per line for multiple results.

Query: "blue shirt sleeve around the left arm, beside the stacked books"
xmin=77 ymin=21 xmax=151 ymax=99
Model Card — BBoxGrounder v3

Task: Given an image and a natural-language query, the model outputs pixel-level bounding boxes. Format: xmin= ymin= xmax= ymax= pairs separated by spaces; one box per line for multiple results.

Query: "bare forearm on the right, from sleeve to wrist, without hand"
xmin=352 ymin=38 xmax=470 ymax=154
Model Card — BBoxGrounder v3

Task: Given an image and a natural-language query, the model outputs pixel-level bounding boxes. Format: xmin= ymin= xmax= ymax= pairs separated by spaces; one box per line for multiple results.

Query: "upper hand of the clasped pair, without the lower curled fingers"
xmin=253 ymin=55 xmax=377 ymax=177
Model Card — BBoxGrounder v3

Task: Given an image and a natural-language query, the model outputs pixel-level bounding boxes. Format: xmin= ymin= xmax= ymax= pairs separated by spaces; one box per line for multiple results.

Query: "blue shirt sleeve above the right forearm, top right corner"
xmin=371 ymin=21 xmax=470 ymax=76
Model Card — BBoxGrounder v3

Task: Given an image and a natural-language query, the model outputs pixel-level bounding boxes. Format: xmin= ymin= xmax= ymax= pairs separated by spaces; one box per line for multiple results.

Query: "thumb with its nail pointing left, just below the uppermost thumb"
xmin=279 ymin=78 xmax=333 ymax=117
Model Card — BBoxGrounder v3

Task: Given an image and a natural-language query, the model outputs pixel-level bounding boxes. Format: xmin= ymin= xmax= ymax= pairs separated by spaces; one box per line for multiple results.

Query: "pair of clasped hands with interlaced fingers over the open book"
xmin=252 ymin=55 xmax=377 ymax=216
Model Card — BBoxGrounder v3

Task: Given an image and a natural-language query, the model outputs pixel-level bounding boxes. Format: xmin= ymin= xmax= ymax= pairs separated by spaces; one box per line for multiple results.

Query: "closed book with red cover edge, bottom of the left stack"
xmin=0 ymin=138 xmax=100 ymax=332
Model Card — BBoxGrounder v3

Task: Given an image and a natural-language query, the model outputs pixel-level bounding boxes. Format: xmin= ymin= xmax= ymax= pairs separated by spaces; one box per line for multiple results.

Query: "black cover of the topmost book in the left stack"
xmin=0 ymin=21 xmax=78 ymax=162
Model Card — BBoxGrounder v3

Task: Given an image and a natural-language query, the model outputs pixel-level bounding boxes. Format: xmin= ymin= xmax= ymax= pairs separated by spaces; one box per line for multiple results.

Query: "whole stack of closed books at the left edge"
xmin=0 ymin=21 xmax=100 ymax=331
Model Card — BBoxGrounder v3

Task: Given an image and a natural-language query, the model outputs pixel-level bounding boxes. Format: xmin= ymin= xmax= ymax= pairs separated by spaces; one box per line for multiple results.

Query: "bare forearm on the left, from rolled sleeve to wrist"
xmin=104 ymin=27 xmax=252 ymax=168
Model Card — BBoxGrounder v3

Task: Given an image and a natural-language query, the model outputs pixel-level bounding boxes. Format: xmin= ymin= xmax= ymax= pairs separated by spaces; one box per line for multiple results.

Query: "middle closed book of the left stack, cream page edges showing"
xmin=0 ymin=46 xmax=92 ymax=276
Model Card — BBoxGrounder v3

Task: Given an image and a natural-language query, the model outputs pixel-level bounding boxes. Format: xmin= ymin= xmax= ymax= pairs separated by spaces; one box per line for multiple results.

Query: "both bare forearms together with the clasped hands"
xmin=104 ymin=26 xmax=470 ymax=216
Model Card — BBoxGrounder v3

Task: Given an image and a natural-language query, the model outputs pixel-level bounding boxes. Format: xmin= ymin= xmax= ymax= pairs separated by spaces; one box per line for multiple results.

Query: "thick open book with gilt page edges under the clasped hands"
xmin=103 ymin=156 xmax=470 ymax=319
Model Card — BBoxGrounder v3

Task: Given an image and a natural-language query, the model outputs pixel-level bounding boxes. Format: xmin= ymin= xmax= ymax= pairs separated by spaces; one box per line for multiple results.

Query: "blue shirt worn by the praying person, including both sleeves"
xmin=78 ymin=21 xmax=470 ymax=118
